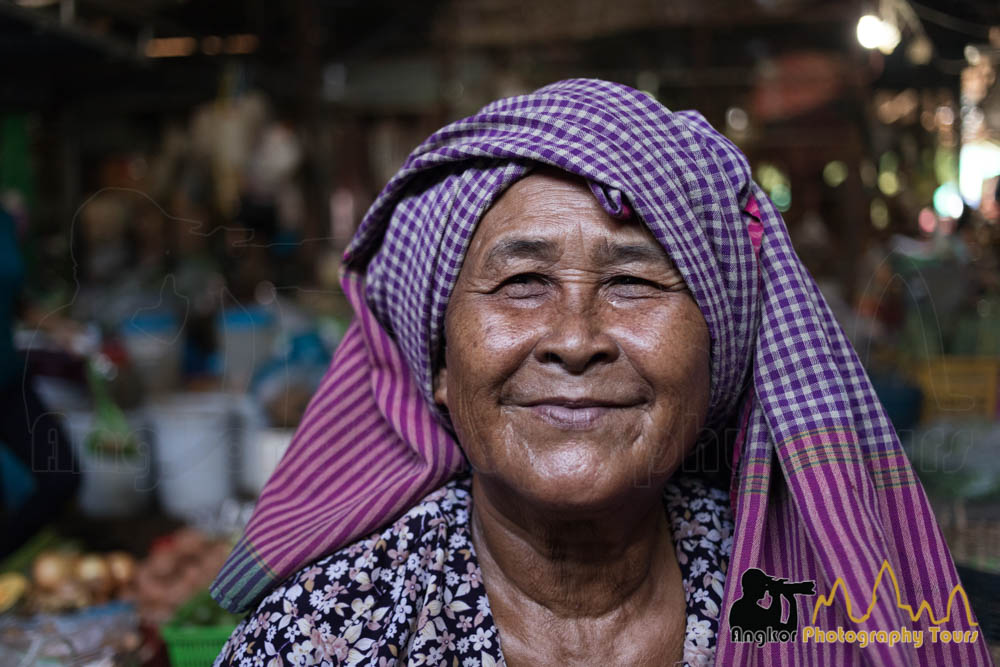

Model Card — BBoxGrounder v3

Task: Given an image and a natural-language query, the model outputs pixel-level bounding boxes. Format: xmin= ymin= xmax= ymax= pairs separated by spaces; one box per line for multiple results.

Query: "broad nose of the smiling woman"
xmin=535 ymin=307 xmax=619 ymax=374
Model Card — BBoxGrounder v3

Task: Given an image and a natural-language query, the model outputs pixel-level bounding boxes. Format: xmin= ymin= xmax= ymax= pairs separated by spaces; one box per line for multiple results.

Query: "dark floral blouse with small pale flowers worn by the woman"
xmin=215 ymin=476 xmax=732 ymax=667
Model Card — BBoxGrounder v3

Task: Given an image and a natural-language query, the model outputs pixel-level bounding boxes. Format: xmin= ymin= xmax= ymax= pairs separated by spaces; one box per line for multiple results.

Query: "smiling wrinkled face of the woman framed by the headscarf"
xmin=434 ymin=172 xmax=709 ymax=509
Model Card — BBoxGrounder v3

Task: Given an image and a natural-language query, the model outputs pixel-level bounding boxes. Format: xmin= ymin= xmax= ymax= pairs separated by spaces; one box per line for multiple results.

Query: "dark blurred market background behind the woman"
xmin=0 ymin=0 xmax=1000 ymax=665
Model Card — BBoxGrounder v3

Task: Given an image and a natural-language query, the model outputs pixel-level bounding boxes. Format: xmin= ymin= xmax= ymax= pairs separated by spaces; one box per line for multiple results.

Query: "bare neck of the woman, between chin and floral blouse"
xmin=472 ymin=476 xmax=685 ymax=664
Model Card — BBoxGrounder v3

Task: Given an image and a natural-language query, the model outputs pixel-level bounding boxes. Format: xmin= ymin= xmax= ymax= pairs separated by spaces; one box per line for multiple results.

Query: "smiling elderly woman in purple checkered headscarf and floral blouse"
xmin=213 ymin=80 xmax=988 ymax=667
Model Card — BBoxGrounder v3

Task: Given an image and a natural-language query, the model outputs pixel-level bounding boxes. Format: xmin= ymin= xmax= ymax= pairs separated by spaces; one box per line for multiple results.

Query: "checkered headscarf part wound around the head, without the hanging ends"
xmin=345 ymin=80 xmax=758 ymax=422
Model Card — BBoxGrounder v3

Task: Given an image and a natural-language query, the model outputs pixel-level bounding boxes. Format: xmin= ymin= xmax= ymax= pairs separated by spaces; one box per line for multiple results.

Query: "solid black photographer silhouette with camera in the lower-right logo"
xmin=729 ymin=567 xmax=816 ymax=646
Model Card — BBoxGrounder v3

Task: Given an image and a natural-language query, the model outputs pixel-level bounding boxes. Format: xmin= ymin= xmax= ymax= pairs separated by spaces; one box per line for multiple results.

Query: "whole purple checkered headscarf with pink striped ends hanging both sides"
xmin=213 ymin=80 xmax=989 ymax=665
